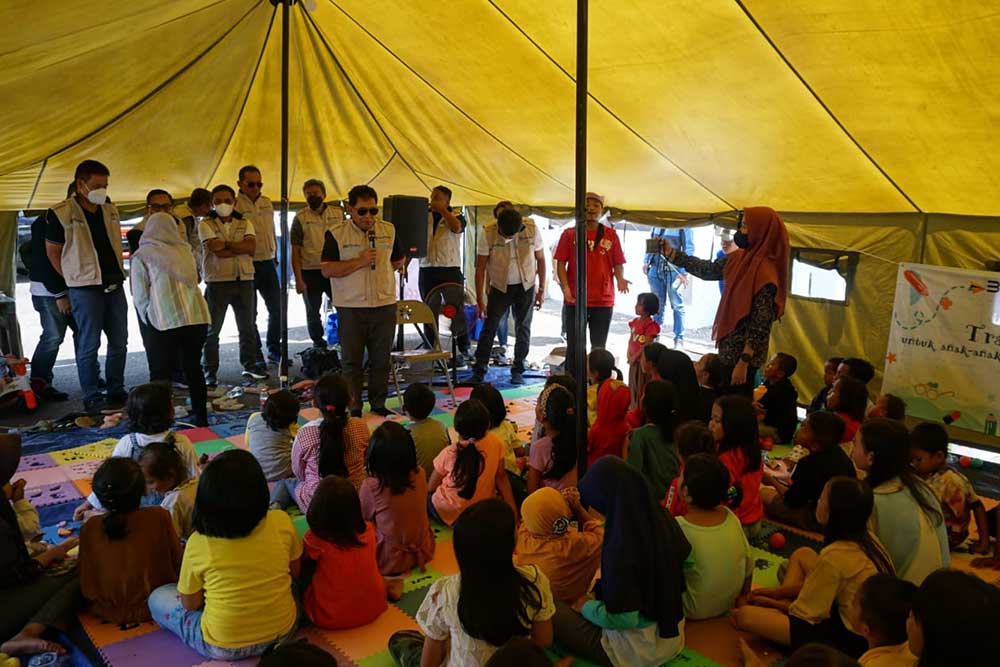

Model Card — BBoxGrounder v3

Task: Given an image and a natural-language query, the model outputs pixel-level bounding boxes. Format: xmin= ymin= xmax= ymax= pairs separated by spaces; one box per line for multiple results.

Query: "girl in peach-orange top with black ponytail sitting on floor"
xmin=428 ymin=398 xmax=517 ymax=526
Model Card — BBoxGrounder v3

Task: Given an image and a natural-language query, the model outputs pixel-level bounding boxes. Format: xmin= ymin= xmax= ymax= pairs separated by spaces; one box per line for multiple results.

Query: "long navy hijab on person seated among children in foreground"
xmin=580 ymin=456 xmax=691 ymax=639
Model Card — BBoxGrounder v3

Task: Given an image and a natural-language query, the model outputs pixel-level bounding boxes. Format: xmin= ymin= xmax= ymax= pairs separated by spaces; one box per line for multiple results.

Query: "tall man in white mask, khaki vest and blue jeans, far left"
xmin=45 ymin=160 xmax=128 ymax=411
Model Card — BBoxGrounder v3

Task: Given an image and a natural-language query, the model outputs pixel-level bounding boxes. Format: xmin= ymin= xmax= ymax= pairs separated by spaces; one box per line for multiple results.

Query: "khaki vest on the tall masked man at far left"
xmin=52 ymin=197 xmax=125 ymax=287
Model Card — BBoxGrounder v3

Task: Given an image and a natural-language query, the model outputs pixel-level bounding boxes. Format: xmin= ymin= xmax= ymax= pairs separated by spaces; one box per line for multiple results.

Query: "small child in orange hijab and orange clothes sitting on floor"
xmin=515 ymin=486 xmax=604 ymax=604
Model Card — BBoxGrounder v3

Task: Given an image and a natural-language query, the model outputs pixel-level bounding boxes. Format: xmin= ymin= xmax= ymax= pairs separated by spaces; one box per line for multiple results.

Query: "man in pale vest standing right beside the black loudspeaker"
xmin=418 ymin=185 xmax=469 ymax=365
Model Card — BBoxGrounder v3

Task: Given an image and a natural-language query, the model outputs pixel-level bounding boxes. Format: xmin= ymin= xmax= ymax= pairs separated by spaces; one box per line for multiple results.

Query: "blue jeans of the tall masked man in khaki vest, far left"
xmin=69 ymin=286 xmax=128 ymax=401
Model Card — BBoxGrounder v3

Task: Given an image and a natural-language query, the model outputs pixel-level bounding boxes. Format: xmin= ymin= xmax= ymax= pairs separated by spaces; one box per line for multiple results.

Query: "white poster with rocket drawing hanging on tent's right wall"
xmin=883 ymin=264 xmax=1000 ymax=437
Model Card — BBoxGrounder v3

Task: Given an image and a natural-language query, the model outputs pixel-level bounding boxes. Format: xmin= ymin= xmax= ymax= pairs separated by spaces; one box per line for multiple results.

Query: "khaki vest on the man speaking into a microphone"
xmin=330 ymin=220 xmax=399 ymax=308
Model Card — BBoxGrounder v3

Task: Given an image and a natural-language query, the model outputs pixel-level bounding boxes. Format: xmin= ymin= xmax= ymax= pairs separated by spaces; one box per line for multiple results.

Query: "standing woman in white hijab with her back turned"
xmin=130 ymin=213 xmax=211 ymax=426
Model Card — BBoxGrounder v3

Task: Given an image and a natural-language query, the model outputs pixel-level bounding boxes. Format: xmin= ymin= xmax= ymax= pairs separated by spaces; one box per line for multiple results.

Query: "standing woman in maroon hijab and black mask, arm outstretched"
xmin=661 ymin=206 xmax=790 ymax=396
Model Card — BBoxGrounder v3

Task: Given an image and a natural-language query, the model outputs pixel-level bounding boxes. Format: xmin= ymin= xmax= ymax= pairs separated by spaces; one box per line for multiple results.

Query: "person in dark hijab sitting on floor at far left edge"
xmin=0 ymin=435 xmax=83 ymax=655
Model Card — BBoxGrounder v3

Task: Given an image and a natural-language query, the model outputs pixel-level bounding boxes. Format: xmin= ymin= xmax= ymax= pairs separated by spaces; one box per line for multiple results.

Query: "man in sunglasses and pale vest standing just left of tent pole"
xmin=236 ymin=164 xmax=281 ymax=364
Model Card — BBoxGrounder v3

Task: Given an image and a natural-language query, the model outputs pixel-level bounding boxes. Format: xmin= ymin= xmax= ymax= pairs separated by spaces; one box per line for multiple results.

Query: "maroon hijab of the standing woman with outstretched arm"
xmin=712 ymin=206 xmax=790 ymax=340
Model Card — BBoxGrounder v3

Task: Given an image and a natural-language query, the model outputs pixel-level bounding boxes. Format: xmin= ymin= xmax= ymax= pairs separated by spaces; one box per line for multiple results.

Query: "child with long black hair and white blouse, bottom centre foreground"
xmin=389 ymin=498 xmax=556 ymax=667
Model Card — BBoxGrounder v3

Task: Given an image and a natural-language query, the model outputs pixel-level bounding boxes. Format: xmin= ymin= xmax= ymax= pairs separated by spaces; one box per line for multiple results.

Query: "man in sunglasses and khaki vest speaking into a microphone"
xmin=322 ymin=185 xmax=407 ymax=417
